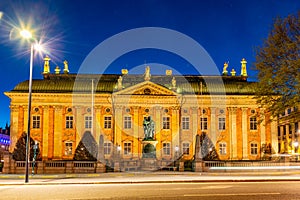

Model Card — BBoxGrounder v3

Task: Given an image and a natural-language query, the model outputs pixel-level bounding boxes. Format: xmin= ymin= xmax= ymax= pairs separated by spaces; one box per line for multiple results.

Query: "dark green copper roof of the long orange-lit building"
xmin=10 ymin=74 xmax=255 ymax=95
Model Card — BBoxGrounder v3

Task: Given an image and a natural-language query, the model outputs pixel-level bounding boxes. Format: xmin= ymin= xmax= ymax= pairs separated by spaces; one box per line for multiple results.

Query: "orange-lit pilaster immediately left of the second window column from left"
xmin=54 ymin=106 xmax=63 ymax=159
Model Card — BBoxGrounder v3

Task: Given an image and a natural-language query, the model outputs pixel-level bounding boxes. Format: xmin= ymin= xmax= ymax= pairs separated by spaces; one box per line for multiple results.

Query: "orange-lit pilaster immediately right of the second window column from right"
xmin=229 ymin=107 xmax=237 ymax=160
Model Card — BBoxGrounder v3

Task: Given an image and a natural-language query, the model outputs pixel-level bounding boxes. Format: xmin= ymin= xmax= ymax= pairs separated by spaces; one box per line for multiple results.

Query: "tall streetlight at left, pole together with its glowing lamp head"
xmin=20 ymin=29 xmax=34 ymax=183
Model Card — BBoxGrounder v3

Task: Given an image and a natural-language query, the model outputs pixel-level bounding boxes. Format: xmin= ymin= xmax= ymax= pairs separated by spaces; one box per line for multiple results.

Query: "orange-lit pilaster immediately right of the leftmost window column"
xmin=41 ymin=106 xmax=51 ymax=160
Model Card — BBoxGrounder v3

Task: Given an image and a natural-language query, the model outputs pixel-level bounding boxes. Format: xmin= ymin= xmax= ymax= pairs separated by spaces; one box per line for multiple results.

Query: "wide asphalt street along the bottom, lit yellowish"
xmin=0 ymin=181 xmax=300 ymax=200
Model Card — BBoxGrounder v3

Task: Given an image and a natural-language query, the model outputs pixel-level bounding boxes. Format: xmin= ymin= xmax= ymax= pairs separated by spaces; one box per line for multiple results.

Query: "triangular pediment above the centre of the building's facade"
xmin=114 ymin=81 xmax=177 ymax=96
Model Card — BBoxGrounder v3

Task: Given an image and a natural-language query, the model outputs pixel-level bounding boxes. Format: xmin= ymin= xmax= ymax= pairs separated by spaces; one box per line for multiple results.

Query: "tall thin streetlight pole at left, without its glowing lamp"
xmin=25 ymin=43 xmax=34 ymax=183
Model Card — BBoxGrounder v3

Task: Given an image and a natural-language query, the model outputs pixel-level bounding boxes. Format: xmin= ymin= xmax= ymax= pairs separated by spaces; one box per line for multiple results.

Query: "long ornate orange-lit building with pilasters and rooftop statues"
xmin=5 ymin=58 xmax=278 ymax=164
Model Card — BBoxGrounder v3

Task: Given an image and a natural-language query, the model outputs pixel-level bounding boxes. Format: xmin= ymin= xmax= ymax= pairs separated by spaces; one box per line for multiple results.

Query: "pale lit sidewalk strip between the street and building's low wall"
xmin=0 ymin=170 xmax=300 ymax=186
